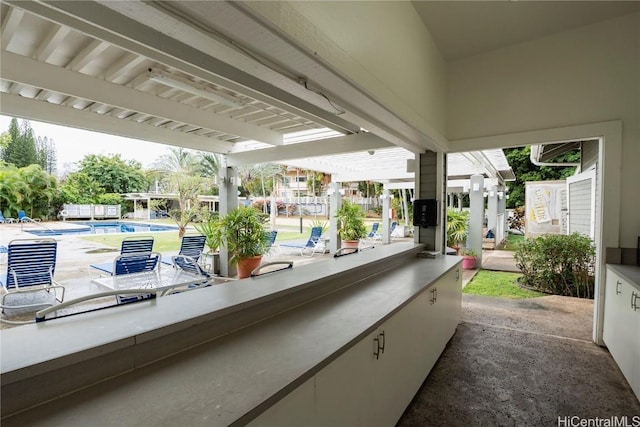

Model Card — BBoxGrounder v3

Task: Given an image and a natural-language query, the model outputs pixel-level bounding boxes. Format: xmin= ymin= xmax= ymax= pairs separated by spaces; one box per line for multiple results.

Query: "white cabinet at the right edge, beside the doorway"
xmin=603 ymin=268 xmax=640 ymax=399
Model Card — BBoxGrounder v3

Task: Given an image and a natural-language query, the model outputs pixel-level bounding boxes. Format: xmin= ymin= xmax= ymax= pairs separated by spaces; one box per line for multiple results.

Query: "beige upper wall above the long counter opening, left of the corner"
xmin=242 ymin=1 xmax=446 ymax=142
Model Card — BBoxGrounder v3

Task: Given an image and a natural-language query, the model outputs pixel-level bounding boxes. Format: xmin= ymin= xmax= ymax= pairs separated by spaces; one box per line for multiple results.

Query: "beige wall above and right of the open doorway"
xmin=446 ymin=14 xmax=640 ymax=247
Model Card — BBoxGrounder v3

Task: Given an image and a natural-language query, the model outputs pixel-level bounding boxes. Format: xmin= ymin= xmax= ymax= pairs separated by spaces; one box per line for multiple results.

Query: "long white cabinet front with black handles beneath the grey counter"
xmin=251 ymin=266 xmax=462 ymax=427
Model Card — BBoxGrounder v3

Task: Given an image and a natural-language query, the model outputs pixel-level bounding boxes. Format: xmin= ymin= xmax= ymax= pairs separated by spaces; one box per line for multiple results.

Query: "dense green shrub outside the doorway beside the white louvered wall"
xmin=515 ymin=233 xmax=595 ymax=298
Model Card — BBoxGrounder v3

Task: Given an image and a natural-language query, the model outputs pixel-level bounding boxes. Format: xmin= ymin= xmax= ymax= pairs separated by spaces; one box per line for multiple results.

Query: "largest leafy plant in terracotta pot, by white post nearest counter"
xmin=213 ymin=206 xmax=267 ymax=279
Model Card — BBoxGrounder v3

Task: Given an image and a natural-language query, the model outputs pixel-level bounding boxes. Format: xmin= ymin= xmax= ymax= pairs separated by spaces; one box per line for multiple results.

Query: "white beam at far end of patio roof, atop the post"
xmin=227 ymin=133 xmax=392 ymax=166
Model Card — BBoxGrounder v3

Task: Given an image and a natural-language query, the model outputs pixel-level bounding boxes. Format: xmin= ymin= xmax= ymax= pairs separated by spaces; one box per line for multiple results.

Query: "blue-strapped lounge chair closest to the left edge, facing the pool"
xmin=0 ymin=239 xmax=65 ymax=312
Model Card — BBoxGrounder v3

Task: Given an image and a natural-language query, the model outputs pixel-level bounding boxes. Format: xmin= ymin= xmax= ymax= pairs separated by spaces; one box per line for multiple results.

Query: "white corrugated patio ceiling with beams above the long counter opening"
xmin=0 ymin=0 xmax=444 ymax=168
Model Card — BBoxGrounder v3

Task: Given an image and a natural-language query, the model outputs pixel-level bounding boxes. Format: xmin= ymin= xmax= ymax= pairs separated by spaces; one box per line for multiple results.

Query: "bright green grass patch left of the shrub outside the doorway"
xmin=462 ymin=270 xmax=546 ymax=299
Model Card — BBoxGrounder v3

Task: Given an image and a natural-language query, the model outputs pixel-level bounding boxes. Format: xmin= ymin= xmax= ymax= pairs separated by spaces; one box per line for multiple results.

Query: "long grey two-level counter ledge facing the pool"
xmin=2 ymin=243 xmax=460 ymax=426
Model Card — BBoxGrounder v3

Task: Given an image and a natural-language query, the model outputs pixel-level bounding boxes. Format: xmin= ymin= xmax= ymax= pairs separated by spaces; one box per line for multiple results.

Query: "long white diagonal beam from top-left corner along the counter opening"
xmin=5 ymin=0 xmax=360 ymax=137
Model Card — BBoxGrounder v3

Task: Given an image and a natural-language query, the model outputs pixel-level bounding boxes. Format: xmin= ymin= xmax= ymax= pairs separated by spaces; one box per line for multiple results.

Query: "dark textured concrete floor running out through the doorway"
xmin=398 ymin=294 xmax=640 ymax=427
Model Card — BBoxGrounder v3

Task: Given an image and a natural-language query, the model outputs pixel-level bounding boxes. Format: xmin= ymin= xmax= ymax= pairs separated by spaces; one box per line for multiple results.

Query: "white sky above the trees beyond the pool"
xmin=0 ymin=115 xmax=169 ymax=176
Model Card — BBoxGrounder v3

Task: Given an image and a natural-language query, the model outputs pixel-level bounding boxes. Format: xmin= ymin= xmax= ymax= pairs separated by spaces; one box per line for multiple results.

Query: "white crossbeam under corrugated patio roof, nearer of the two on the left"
xmin=0 ymin=51 xmax=282 ymax=144
